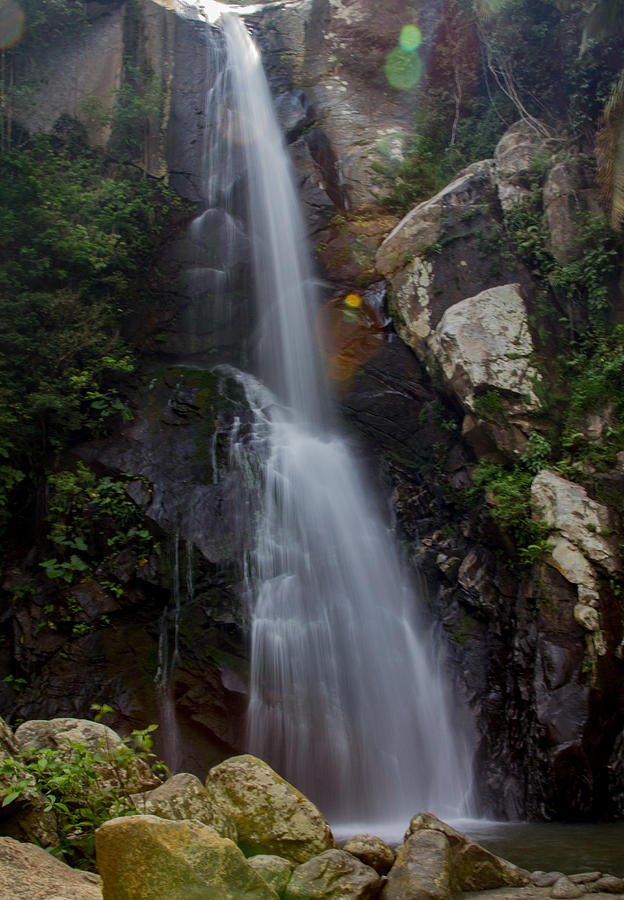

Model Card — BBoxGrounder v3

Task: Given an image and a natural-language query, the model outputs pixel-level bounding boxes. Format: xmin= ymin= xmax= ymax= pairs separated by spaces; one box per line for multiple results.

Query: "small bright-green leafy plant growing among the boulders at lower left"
xmin=0 ymin=707 xmax=166 ymax=869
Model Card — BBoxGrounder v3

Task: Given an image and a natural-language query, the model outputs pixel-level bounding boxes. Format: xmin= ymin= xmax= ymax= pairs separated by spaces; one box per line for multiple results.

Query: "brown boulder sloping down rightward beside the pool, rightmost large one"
xmin=408 ymin=813 xmax=530 ymax=891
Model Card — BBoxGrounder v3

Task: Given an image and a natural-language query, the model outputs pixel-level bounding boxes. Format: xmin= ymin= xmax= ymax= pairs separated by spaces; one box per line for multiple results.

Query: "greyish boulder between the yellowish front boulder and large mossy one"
xmin=132 ymin=772 xmax=238 ymax=843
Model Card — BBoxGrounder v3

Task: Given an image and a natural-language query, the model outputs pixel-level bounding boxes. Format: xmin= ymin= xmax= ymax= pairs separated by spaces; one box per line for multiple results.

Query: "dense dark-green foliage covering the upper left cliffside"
xmin=0 ymin=136 xmax=186 ymax=525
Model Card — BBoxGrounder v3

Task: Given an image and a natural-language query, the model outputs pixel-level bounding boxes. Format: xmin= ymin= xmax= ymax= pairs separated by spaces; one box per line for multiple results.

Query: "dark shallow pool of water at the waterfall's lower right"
xmin=464 ymin=821 xmax=624 ymax=877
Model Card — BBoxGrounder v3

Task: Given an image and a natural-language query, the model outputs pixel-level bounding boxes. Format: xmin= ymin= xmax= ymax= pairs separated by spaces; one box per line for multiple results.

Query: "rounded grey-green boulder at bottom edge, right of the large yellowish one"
xmin=284 ymin=850 xmax=381 ymax=900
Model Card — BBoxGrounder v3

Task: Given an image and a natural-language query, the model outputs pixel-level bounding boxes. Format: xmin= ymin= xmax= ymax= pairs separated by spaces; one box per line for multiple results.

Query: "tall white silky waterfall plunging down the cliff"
xmin=173 ymin=4 xmax=470 ymax=831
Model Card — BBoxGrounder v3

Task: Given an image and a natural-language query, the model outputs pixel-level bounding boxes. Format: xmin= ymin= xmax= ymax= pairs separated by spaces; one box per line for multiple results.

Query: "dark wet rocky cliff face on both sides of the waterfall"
xmin=2 ymin=0 xmax=624 ymax=819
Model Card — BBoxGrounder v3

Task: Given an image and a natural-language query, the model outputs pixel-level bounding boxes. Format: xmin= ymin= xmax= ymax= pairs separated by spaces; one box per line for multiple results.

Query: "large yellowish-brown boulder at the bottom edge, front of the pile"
xmin=95 ymin=816 xmax=277 ymax=900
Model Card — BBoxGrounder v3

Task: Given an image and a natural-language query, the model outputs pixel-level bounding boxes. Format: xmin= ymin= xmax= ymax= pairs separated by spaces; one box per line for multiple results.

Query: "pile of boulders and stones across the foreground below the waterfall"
xmin=0 ymin=718 xmax=624 ymax=900
